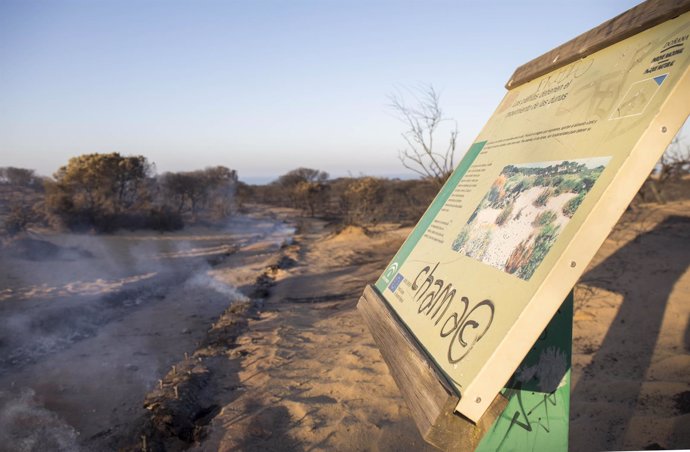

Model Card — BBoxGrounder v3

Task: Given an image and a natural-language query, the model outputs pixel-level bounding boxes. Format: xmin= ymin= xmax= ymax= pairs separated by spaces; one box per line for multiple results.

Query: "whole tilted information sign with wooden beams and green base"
xmin=358 ymin=0 xmax=690 ymax=451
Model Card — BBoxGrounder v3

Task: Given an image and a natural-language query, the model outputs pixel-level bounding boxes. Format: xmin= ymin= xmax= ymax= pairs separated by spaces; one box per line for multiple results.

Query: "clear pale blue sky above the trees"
xmin=0 ymin=0 xmax=638 ymax=182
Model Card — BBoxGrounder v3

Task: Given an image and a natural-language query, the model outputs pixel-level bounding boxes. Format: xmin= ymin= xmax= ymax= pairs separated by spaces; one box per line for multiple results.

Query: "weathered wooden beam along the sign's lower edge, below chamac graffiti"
xmin=357 ymin=285 xmax=507 ymax=451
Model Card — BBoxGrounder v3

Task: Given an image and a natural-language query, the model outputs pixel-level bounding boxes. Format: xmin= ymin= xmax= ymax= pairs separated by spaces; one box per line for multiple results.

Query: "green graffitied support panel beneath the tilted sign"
xmin=476 ymin=292 xmax=573 ymax=452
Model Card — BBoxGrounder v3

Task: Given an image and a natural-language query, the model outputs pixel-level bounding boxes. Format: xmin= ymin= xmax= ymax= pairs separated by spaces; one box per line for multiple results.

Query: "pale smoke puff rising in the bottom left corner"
xmin=0 ymin=389 xmax=79 ymax=452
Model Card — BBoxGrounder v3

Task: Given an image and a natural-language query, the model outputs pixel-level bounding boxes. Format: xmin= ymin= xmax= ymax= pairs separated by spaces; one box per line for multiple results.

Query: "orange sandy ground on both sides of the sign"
xmin=189 ymin=203 xmax=690 ymax=451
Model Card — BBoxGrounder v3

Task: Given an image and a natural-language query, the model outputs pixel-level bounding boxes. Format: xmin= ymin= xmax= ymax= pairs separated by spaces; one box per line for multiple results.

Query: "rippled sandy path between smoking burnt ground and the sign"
xmin=198 ymin=222 xmax=431 ymax=451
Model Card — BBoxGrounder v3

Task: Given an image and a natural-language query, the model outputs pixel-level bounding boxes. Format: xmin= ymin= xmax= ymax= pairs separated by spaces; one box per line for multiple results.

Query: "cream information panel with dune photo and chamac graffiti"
xmin=376 ymin=10 xmax=690 ymax=420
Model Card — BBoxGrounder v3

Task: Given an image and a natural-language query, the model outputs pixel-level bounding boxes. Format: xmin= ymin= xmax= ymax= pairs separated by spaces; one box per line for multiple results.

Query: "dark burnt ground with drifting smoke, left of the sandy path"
xmin=0 ymin=213 xmax=294 ymax=450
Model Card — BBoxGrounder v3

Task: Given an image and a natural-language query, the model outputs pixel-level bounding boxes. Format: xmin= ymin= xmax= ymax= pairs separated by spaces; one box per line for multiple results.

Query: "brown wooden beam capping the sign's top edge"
xmin=506 ymin=0 xmax=690 ymax=90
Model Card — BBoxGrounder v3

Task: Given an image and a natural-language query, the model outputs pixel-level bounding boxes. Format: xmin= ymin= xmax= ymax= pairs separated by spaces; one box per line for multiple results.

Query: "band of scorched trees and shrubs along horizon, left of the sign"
xmin=0 ymin=157 xmax=438 ymax=235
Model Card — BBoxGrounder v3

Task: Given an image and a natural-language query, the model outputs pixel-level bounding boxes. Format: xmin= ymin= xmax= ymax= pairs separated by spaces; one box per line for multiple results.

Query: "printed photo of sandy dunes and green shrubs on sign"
xmin=451 ymin=157 xmax=610 ymax=280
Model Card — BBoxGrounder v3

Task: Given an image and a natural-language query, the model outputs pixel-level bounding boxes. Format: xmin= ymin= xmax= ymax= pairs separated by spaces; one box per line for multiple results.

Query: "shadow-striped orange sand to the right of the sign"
xmin=570 ymin=201 xmax=690 ymax=451
